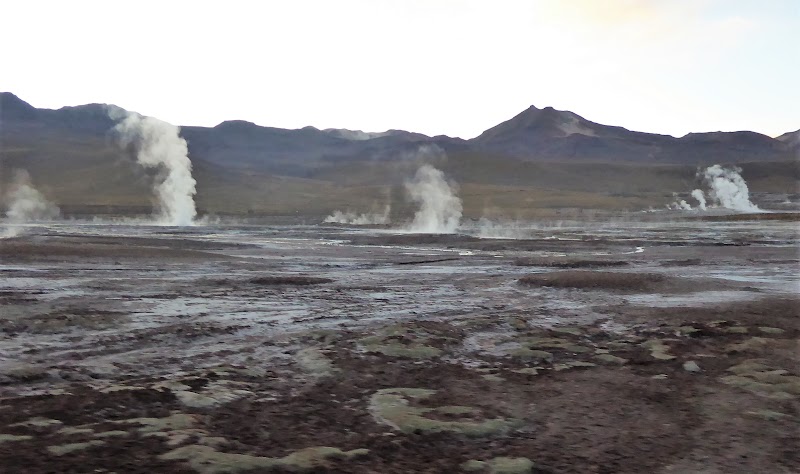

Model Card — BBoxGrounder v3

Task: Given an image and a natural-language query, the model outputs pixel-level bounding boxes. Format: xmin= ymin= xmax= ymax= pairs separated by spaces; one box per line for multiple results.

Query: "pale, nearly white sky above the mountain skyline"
xmin=0 ymin=0 xmax=800 ymax=138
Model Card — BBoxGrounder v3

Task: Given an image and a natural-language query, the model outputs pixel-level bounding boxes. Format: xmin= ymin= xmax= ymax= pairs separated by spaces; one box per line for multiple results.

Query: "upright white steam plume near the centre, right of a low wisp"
xmin=405 ymin=164 xmax=463 ymax=234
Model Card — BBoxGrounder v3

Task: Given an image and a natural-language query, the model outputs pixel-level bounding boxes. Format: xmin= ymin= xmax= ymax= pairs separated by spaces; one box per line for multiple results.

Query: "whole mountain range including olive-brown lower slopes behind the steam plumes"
xmin=0 ymin=92 xmax=800 ymax=218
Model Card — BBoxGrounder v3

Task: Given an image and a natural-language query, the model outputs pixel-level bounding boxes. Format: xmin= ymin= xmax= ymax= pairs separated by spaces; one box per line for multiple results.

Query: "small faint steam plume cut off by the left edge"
xmin=0 ymin=170 xmax=61 ymax=237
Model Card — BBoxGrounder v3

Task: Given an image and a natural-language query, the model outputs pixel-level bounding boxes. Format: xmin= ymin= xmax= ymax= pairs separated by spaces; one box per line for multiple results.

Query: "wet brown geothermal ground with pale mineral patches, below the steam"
xmin=0 ymin=219 xmax=800 ymax=473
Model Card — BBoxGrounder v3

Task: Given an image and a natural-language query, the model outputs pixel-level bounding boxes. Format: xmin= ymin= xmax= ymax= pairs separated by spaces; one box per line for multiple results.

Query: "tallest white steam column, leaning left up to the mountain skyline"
xmin=109 ymin=108 xmax=197 ymax=226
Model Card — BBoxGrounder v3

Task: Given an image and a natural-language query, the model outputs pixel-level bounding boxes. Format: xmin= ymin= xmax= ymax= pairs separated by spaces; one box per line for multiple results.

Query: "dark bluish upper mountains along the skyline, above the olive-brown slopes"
xmin=0 ymin=92 xmax=800 ymax=175
